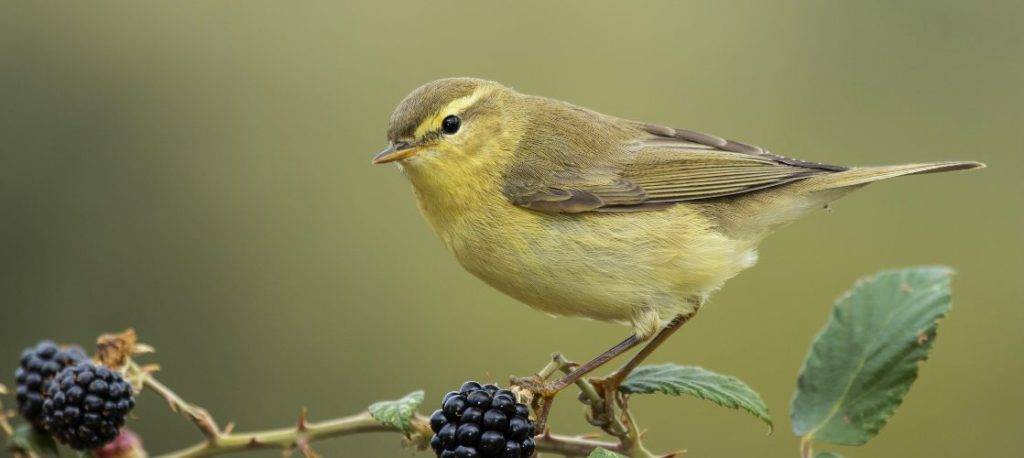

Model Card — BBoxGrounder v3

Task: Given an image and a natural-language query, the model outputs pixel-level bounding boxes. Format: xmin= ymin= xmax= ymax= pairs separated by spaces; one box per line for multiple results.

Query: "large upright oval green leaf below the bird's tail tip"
xmin=790 ymin=266 xmax=952 ymax=446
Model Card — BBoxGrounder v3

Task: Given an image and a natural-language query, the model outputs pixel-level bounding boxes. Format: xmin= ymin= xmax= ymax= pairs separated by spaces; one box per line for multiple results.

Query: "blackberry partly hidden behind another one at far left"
xmin=14 ymin=340 xmax=88 ymax=428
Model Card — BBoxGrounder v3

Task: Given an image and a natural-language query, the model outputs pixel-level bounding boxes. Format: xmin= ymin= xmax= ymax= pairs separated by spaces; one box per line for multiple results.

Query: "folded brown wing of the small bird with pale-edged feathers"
xmin=505 ymin=124 xmax=846 ymax=213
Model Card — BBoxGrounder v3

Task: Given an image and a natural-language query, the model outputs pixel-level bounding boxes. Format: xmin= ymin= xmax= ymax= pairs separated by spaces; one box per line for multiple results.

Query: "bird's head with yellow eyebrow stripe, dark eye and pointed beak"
xmin=373 ymin=78 xmax=520 ymax=175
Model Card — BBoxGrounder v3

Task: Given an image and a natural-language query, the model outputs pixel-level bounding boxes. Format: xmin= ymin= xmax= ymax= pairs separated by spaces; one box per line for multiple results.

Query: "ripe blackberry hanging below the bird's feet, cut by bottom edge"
xmin=430 ymin=381 xmax=537 ymax=458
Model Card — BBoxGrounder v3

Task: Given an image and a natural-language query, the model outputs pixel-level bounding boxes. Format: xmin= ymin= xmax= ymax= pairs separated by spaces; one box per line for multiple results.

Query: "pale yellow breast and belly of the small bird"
xmin=403 ymin=156 xmax=755 ymax=332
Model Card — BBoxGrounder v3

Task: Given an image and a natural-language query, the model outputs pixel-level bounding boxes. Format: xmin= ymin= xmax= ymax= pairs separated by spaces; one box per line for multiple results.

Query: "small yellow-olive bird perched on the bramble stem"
xmin=373 ymin=78 xmax=984 ymax=397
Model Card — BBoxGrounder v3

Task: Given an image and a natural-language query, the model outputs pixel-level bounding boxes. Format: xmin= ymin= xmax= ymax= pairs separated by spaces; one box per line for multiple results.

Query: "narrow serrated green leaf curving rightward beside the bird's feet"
xmin=618 ymin=364 xmax=772 ymax=430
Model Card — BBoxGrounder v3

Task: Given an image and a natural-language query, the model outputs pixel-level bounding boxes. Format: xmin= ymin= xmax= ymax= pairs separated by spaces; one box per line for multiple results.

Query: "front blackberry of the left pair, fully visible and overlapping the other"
xmin=43 ymin=362 xmax=135 ymax=450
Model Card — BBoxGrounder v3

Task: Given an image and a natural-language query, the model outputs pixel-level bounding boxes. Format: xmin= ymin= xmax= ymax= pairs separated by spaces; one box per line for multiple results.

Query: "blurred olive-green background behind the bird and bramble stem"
xmin=0 ymin=1 xmax=1024 ymax=457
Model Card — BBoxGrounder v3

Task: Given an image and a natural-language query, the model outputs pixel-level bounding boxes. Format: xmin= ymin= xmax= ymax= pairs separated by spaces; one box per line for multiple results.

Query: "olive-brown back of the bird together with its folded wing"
xmin=503 ymin=95 xmax=846 ymax=213
